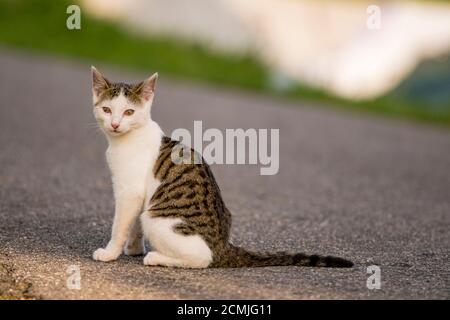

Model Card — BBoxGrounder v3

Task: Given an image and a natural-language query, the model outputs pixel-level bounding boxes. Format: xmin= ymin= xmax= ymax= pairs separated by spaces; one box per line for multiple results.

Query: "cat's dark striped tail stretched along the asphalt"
xmin=217 ymin=244 xmax=353 ymax=268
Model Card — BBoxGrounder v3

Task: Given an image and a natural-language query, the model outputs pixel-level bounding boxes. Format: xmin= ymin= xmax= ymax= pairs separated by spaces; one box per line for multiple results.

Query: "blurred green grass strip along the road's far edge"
xmin=0 ymin=0 xmax=450 ymax=126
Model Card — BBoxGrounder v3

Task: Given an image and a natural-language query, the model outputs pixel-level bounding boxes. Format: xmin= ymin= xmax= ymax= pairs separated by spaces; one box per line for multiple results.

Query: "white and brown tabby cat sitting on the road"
xmin=92 ymin=67 xmax=353 ymax=268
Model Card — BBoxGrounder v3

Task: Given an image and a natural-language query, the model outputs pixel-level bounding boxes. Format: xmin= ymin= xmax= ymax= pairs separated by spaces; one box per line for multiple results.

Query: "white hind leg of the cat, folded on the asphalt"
xmin=141 ymin=212 xmax=212 ymax=268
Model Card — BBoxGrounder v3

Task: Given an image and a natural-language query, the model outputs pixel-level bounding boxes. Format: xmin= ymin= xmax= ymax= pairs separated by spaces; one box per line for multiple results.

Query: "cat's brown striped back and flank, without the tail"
xmin=150 ymin=137 xmax=231 ymax=238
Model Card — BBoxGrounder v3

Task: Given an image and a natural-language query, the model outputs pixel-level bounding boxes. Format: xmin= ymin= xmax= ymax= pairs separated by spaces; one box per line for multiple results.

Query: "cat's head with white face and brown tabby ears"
xmin=92 ymin=67 xmax=158 ymax=137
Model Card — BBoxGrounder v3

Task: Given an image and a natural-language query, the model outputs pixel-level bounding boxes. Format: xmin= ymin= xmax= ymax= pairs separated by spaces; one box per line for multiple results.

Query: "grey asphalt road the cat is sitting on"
xmin=0 ymin=49 xmax=450 ymax=299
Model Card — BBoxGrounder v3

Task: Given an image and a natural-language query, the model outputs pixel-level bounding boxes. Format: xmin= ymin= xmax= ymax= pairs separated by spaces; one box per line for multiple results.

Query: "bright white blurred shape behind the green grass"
xmin=85 ymin=0 xmax=450 ymax=99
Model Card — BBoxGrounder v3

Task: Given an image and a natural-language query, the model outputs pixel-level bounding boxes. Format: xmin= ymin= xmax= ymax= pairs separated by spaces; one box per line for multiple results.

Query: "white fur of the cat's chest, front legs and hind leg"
xmin=94 ymin=121 xmax=212 ymax=268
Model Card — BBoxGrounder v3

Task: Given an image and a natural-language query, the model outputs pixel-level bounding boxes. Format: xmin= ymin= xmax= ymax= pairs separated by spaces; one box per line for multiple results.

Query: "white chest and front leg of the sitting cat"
xmin=94 ymin=116 xmax=163 ymax=261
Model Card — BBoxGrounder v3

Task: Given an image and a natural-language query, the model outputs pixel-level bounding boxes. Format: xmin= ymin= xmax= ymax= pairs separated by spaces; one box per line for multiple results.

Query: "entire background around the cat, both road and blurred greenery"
xmin=0 ymin=0 xmax=450 ymax=300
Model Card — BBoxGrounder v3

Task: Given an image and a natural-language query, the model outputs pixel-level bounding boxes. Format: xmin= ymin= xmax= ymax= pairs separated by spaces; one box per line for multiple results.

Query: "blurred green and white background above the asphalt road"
xmin=0 ymin=0 xmax=450 ymax=125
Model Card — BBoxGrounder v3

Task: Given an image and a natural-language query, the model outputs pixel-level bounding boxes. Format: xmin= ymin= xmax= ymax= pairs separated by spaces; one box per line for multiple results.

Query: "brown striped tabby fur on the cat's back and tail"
xmin=148 ymin=137 xmax=353 ymax=267
